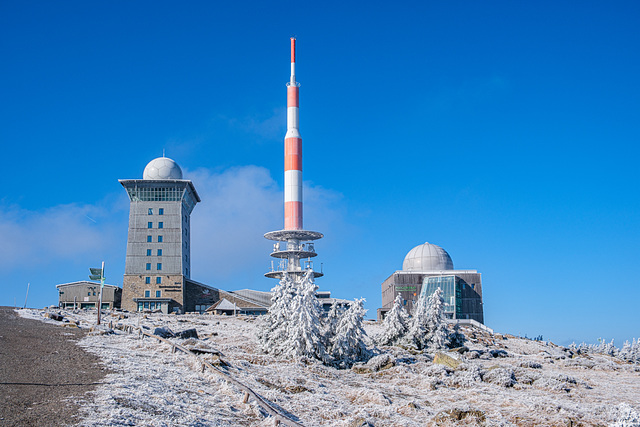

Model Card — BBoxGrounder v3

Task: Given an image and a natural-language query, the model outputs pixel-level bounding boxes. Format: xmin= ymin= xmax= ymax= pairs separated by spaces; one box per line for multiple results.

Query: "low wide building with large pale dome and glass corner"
xmin=378 ymin=242 xmax=484 ymax=323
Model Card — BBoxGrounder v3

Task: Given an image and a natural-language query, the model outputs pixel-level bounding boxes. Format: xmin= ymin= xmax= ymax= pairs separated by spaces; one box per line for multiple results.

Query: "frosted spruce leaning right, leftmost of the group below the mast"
xmin=258 ymin=273 xmax=296 ymax=356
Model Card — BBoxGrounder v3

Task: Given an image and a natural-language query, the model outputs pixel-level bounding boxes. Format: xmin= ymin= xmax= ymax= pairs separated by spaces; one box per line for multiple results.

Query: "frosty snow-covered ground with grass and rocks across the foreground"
xmin=19 ymin=310 xmax=640 ymax=426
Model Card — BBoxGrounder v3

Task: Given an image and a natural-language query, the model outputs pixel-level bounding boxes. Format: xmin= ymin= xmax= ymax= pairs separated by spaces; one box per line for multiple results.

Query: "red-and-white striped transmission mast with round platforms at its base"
xmin=264 ymin=37 xmax=324 ymax=280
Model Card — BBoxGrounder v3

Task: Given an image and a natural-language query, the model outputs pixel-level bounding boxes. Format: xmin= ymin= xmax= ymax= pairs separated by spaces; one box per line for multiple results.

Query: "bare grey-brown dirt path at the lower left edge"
xmin=0 ymin=307 xmax=107 ymax=426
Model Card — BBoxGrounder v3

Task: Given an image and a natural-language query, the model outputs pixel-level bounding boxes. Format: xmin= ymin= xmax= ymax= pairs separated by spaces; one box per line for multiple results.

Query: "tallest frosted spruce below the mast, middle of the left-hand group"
xmin=282 ymin=270 xmax=326 ymax=362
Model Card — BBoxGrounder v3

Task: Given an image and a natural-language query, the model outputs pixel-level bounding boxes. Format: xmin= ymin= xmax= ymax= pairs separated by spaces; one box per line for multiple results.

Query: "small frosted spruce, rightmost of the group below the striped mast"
xmin=331 ymin=298 xmax=371 ymax=367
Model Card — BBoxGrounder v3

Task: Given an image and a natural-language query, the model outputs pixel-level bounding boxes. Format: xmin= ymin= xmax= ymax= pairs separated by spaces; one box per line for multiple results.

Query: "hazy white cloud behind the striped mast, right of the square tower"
xmin=185 ymin=166 xmax=342 ymax=288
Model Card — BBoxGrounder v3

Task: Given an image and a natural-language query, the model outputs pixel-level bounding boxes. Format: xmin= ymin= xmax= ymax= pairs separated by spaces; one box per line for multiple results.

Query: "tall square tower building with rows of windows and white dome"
xmin=119 ymin=157 xmax=200 ymax=313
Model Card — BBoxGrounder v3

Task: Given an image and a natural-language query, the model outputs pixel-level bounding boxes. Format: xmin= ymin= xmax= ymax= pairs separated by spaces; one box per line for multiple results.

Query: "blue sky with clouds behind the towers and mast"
xmin=0 ymin=1 xmax=640 ymax=345
